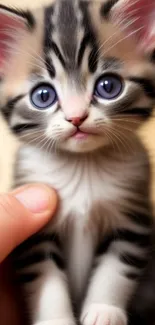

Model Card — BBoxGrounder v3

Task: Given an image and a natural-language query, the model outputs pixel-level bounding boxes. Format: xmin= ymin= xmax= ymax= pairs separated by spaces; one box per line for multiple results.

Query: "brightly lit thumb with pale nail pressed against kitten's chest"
xmin=0 ymin=184 xmax=58 ymax=262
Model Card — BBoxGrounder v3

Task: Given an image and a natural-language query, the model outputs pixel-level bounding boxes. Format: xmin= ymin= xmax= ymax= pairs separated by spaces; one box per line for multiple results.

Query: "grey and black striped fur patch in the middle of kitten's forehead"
xmin=45 ymin=0 xmax=97 ymax=72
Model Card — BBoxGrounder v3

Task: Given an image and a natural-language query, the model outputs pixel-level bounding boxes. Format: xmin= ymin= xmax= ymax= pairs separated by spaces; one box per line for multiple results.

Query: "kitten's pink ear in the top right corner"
xmin=111 ymin=0 xmax=155 ymax=52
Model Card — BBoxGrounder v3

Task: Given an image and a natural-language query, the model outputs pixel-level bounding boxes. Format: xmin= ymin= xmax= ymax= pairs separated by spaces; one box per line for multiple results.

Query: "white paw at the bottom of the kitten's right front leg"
xmin=81 ymin=304 xmax=127 ymax=325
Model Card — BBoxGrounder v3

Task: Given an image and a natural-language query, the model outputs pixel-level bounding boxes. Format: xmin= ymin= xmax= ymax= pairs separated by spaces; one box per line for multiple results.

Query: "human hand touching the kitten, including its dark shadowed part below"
xmin=0 ymin=184 xmax=57 ymax=325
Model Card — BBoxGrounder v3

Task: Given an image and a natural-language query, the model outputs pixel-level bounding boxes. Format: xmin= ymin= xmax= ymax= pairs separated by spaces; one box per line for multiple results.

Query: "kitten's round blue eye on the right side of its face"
xmin=94 ymin=75 xmax=123 ymax=100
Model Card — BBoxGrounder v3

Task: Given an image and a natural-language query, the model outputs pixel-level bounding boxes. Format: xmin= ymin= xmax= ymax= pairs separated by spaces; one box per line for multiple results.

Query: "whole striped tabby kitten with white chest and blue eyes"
xmin=0 ymin=0 xmax=155 ymax=325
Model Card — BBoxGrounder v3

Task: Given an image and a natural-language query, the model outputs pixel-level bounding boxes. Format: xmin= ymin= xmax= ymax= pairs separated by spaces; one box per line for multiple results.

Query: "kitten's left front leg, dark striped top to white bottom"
xmin=13 ymin=233 xmax=75 ymax=325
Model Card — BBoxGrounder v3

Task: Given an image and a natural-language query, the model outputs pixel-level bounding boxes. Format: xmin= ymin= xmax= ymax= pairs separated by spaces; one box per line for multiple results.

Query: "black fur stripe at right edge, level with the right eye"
xmin=128 ymin=77 xmax=155 ymax=98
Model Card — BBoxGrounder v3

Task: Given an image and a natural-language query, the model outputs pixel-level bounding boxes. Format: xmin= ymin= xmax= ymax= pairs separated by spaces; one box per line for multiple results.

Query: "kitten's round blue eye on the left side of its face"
xmin=31 ymin=84 xmax=58 ymax=109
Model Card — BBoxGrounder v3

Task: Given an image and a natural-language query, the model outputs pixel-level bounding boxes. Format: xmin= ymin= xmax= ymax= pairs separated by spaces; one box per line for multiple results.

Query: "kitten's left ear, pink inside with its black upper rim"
xmin=0 ymin=5 xmax=34 ymax=68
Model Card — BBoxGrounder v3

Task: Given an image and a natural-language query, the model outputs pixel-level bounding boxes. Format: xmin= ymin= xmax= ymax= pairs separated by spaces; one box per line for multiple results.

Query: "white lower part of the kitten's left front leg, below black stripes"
xmin=29 ymin=262 xmax=75 ymax=325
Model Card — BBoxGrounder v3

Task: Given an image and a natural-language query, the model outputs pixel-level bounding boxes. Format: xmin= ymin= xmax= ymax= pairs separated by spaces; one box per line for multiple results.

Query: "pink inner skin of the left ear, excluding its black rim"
xmin=0 ymin=12 xmax=25 ymax=68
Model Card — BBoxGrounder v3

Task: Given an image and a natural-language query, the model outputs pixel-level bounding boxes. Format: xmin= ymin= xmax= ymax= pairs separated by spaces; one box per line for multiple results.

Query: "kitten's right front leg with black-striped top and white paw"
xmin=81 ymin=216 xmax=150 ymax=325
